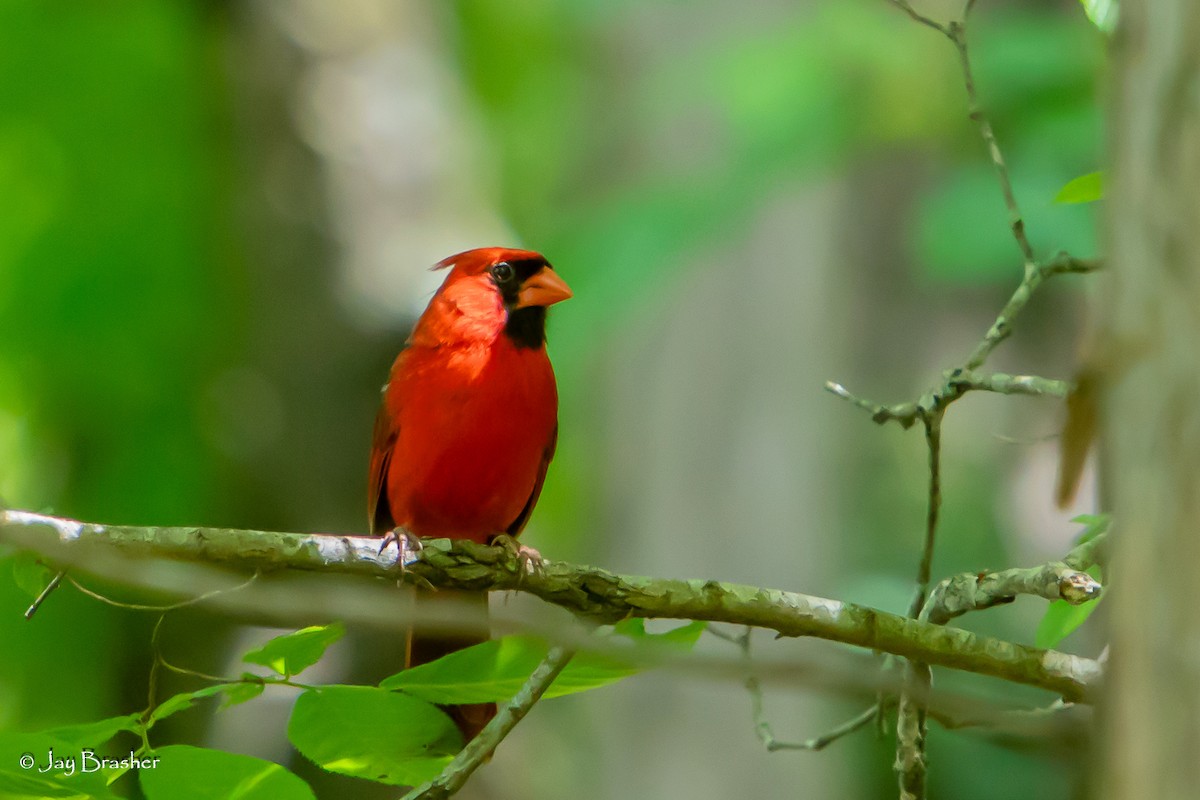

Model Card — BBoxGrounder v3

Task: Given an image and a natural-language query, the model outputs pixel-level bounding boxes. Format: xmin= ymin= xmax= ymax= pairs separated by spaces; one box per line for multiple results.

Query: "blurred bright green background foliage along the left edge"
xmin=0 ymin=0 xmax=245 ymax=758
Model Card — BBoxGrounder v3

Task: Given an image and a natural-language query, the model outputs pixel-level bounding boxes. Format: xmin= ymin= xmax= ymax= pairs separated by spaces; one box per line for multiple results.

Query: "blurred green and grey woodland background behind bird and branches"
xmin=0 ymin=0 xmax=1104 ymax=799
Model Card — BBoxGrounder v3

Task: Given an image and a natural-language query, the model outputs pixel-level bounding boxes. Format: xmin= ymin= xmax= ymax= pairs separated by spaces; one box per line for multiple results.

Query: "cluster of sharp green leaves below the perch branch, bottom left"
xmin=0 ymin=619 xmax=704 ymax=800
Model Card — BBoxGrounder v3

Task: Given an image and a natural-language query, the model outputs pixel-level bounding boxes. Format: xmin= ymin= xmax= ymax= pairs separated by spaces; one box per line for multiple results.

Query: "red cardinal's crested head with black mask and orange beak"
xmin=426 ymin=247 xmax=571 ymax=348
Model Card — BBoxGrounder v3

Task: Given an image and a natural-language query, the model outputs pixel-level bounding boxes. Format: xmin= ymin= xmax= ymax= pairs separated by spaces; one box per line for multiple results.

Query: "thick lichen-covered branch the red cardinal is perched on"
xmin=0 ymin=511 xmax=1102 ymax=702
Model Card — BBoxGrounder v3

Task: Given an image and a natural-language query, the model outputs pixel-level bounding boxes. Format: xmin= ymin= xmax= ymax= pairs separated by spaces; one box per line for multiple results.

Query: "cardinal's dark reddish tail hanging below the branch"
xmin=404 ymin=589 xmax=496 ymax=741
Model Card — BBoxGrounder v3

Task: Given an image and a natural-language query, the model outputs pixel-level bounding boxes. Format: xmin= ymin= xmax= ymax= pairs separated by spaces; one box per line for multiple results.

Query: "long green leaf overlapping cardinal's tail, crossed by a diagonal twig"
xmin=379 ymin=619 xmax=704 ymax=704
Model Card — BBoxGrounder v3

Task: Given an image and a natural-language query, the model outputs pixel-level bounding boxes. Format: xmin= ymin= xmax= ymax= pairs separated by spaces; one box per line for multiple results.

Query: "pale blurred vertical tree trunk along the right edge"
xmin=1098 ymin=0 xmax=1200 ymax=798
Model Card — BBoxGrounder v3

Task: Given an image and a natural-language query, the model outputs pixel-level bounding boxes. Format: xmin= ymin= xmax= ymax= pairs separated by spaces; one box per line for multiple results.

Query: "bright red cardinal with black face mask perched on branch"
xmin=367 ymin=247 xmax=571 ymax=740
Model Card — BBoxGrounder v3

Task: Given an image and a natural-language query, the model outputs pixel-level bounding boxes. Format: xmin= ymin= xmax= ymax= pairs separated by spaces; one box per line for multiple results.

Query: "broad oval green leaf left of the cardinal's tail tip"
xmin=288 ymin=686 xmax=463 ymax=786
